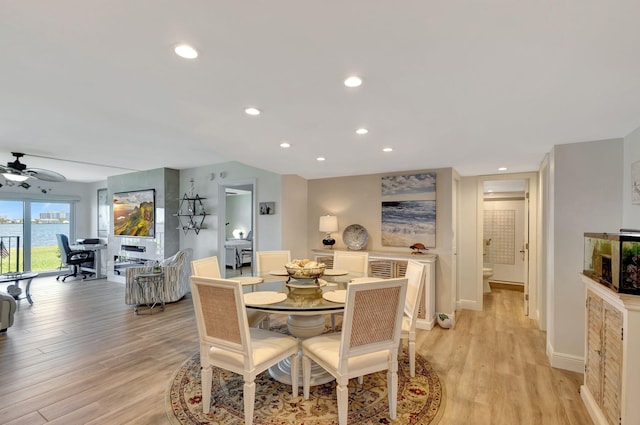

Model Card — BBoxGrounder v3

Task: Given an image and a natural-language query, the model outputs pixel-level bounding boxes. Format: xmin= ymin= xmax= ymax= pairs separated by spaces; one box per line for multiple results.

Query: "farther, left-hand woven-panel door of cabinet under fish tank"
xmin=584 ymin=291 xmax=604 ymax=406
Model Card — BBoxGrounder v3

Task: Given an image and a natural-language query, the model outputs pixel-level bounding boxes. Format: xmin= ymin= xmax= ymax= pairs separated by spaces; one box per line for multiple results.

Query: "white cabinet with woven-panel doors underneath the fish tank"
xmin=580 ymin=276 xmax=640 ymax=425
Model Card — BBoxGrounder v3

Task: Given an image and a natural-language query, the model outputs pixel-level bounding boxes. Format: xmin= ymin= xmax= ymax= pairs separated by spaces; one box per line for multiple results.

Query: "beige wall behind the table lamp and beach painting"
xmin=306 ymin=168 xmax=455 ymax=313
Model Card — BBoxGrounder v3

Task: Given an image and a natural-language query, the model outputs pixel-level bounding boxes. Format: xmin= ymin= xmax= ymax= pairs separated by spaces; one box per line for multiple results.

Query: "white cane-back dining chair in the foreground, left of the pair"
xmin=190 ymin=276 xmax=298 ymax=425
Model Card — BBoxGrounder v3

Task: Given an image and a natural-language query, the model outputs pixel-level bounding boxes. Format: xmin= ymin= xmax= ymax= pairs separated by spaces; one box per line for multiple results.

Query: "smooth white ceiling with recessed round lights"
xmin=0 ymin=0 xmax=640 ymax=181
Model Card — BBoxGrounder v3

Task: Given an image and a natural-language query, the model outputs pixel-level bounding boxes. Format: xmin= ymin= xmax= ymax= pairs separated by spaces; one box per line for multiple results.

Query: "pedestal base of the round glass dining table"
xmin=269 ymin=314 xmax=335 ymax=386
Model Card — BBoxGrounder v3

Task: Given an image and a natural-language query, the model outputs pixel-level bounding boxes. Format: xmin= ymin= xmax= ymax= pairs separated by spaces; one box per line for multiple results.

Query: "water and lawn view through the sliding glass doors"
xmin=0 ymin=200 xmax=71 ymax=272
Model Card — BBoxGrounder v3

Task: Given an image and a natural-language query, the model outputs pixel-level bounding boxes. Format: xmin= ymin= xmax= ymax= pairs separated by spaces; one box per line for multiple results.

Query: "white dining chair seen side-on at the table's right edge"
xmin=399 ymin=260 xmax=426 ymax=378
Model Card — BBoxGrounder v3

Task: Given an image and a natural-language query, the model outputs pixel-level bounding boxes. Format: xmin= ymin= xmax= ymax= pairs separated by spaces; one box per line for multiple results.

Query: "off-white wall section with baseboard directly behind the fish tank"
xmin=547 ymin=139 xmax=623 ymax=371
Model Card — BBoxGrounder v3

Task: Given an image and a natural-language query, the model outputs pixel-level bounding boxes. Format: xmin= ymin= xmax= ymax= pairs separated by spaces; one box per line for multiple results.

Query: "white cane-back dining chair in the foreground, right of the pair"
xmin=302 ymin=278 xmax=407 ymax=425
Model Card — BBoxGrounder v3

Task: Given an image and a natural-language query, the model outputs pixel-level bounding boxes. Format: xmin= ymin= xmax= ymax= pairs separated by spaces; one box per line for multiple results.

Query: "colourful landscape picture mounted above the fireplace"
xmin=113 ymin=189 xmax=156 ymax=238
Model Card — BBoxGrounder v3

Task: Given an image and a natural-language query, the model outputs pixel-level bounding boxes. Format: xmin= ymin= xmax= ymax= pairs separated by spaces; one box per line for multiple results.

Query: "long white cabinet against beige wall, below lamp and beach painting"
xmin=312 ymin=249 xmax=438 ymax=329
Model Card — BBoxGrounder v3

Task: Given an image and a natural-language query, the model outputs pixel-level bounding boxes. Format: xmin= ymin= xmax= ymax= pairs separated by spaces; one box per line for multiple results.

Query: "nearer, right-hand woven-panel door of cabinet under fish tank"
xmin=602 ymin=302 xmax=623 ymax=425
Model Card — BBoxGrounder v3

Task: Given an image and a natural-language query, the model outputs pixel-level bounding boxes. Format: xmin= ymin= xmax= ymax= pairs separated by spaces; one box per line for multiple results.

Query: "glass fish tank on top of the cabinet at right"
xmin=583 ymin=229 xmax=640 ymax=295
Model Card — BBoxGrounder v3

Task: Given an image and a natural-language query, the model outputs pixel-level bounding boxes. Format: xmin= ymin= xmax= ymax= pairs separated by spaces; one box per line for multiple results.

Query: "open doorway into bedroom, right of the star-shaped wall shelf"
xmin=221 ymin=183 xmax=255 ymax=278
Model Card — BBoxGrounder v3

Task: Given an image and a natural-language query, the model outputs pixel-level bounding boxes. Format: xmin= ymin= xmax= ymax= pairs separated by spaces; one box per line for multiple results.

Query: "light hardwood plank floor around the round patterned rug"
xmin=0 ymin=278 xmax=591 ymax=425
